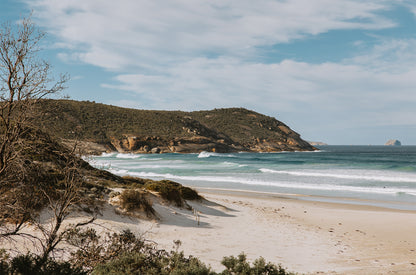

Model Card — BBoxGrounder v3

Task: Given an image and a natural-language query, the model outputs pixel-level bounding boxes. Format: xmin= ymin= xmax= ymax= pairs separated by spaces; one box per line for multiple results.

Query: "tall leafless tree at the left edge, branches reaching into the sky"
xmin=0 ymin=18 xmax=67 ymax=236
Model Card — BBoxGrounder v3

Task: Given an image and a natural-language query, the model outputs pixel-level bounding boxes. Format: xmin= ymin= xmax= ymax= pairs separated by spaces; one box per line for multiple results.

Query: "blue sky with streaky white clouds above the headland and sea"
xmin=0 ymin=0 xmax=416 ymax=145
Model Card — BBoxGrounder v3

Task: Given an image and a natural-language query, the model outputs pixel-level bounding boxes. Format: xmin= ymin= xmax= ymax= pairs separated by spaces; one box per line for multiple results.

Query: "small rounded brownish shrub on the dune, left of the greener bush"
xmin=120 ymin=189 xmax=156 ymax=217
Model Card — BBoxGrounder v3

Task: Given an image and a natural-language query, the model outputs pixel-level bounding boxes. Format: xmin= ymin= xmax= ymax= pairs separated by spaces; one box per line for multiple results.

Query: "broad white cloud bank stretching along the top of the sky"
xmin=27 ymin=0 xmax=395 ymax=71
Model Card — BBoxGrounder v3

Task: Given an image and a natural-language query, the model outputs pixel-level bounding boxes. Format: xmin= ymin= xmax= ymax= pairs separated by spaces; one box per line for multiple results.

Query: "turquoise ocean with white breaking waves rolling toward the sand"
xmin=89 ymin=146 xmax=416 ymax=210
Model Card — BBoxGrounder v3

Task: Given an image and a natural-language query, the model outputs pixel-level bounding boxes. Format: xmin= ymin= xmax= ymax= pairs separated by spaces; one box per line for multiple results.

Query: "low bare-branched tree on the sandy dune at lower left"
xmin=0 ymin=132 xmax=101 ymax=268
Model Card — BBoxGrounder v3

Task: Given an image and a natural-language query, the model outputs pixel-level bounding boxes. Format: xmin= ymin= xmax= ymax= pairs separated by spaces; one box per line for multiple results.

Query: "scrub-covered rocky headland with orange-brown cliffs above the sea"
xmin=39 ymin=100 xmax=315 ymax=153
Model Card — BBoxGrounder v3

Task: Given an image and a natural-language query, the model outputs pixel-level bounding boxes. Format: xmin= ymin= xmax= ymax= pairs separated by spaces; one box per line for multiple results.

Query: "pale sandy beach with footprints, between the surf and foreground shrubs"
xmin=101 ymin=189 xmax=416 ymax=274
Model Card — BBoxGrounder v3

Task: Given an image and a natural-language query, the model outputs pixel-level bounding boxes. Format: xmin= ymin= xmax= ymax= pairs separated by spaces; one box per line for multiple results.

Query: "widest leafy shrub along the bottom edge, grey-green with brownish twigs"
xmin=67 ymin=229 xmax=214 ymax=275
